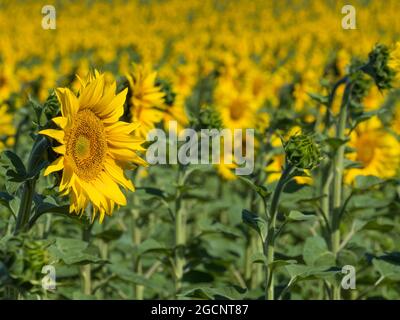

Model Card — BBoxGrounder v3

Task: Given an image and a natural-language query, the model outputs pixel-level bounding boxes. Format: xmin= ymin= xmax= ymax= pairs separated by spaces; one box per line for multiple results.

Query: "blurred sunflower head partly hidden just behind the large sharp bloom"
xmin=127 ymin=65 xmax=165 ymax=138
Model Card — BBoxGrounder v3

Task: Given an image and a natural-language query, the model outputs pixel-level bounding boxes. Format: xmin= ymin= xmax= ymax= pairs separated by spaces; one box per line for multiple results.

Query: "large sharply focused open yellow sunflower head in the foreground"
xmin=40 ymin=71 xmax=146 ymax=222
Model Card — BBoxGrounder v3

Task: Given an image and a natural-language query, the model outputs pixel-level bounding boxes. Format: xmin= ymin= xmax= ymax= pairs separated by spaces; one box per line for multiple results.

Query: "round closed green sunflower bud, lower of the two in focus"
xmin=284 ymin=134 xmax=322 ymax=169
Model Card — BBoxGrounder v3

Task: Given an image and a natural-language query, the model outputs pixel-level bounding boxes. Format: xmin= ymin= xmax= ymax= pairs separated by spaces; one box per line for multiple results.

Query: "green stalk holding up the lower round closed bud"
xmin=264 ymin=164 xmax=294 ymax=300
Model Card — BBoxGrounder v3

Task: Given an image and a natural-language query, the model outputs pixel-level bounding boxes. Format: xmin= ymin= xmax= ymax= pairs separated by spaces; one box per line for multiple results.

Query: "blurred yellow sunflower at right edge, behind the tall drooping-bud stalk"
xmin=345 ymin=116 xmax=400 ymax=183
